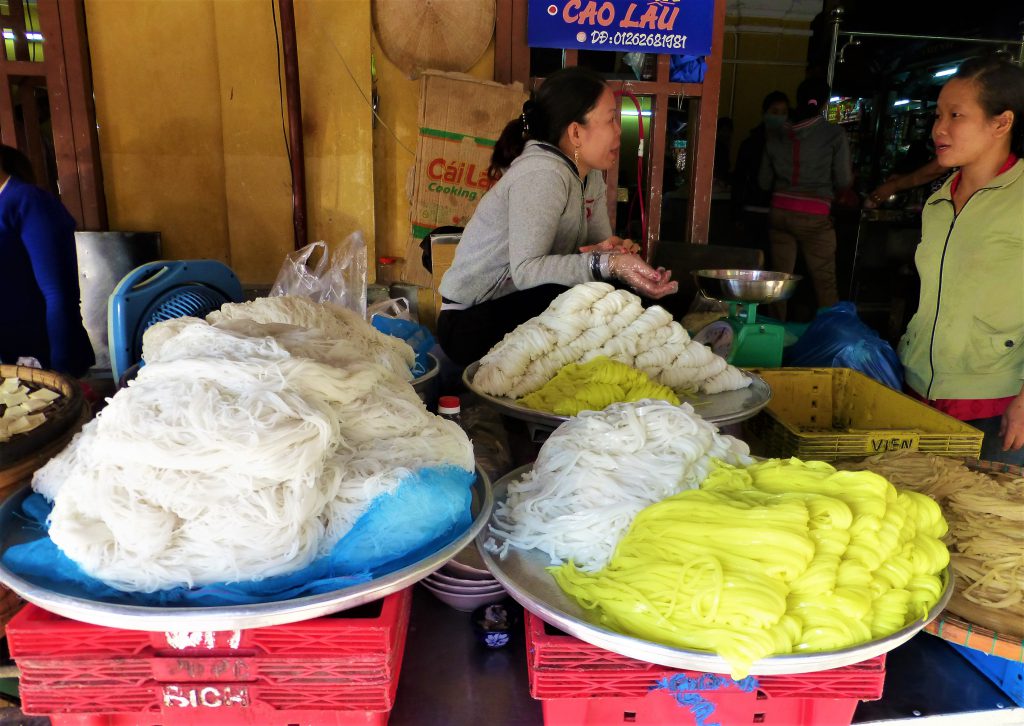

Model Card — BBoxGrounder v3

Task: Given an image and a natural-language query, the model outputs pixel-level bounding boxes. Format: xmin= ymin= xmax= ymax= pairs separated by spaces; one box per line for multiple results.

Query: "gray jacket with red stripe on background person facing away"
xmin=758 ymin=116 xmax=853 ymax=200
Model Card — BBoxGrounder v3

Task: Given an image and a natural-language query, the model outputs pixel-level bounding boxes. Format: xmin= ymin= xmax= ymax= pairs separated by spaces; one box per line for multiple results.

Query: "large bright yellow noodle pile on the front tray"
xmin=550 ymin=459 xmax=949 ymax=679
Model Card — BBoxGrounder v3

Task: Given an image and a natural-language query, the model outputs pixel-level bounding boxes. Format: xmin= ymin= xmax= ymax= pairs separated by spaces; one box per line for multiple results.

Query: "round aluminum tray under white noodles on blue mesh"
xmin=0 ymin=469 xmax=494 ymax=632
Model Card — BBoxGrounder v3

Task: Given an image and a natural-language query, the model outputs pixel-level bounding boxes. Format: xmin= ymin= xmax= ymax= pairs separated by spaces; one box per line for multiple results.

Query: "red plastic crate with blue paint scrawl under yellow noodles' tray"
xmin=525 ymin=612 xmax=885 ymax=726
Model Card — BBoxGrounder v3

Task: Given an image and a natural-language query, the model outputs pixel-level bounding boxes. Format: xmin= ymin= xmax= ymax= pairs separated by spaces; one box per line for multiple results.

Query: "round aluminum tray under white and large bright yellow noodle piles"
xmin=476 ymin=465 xmax=953 ymax=676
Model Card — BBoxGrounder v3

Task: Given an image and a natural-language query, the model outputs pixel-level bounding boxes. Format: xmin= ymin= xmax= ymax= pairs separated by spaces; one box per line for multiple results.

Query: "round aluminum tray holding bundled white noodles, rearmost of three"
xmin=462 ymin=360 xmax=771 ymax=428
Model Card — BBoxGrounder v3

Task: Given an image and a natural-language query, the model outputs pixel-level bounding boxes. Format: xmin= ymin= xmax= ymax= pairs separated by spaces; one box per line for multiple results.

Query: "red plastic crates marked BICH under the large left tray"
xmin=8 ymin=589 xmax=412 ymax=726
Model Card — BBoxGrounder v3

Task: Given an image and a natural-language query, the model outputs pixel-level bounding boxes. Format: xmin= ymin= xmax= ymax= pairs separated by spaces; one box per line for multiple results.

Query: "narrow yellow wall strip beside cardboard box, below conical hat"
xmin=374 ymin=31 xmax=495 ymax=274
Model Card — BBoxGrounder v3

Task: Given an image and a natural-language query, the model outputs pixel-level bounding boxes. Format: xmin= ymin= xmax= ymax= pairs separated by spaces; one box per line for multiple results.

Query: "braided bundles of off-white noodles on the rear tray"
xmin=473 ymin=283 xmax=751 ymax=398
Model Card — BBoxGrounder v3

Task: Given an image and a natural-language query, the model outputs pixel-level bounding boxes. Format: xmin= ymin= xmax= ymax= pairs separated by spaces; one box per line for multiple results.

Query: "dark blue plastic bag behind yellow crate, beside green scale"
xmin=783 ymin=302 xmax=903 ymax=391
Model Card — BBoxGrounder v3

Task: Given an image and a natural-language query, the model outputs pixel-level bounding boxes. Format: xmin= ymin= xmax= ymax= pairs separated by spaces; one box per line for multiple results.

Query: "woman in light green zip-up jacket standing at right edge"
xmin=899 ymin=56 xmax=1024 ymax=465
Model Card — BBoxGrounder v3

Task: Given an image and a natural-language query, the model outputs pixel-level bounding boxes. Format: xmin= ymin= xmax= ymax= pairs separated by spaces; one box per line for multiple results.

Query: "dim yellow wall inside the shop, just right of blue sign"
xmin=719 ymin=16 xmax=810 ymax=168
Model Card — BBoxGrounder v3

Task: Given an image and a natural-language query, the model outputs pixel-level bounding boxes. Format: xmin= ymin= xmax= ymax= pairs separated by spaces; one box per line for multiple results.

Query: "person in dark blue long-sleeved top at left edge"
xmin=0 ymin=145 xmax=95 ymax=377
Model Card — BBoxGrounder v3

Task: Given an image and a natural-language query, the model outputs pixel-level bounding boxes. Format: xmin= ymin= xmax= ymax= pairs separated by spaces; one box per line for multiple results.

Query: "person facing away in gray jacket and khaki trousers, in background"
xmin=758 ymin=78 xmax=853 ymax=319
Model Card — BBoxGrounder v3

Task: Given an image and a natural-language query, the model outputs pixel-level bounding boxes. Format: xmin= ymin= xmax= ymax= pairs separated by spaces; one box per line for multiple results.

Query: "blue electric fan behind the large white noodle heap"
xmin=106 ymin=260 xmax=242 ymax=381
